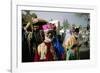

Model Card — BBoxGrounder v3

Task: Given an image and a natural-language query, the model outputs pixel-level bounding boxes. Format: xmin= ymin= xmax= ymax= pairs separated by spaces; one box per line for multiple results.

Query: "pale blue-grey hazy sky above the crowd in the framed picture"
xmin=22 ymin=11 xmax=89 ymax=26
